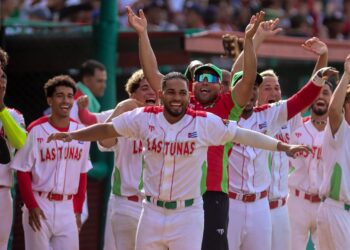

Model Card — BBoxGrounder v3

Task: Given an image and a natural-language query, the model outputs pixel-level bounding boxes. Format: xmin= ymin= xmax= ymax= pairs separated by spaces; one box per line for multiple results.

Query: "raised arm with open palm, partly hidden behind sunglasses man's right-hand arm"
xmin=231 ymin=18 xmax=282 ymax=74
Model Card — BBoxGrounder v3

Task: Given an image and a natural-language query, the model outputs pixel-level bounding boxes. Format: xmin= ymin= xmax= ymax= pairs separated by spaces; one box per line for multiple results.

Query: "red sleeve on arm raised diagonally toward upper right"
xmin=287 ymin=81 xmax=322 ymax=120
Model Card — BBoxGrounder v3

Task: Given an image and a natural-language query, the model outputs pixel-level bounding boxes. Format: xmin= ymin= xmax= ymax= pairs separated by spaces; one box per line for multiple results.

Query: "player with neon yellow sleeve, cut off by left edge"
xmin=0 ymin=48 xmax=27 ymax=250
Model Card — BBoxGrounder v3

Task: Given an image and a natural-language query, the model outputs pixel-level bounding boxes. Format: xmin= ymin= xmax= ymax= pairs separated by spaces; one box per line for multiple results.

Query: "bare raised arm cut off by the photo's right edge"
xmin=328 ymin=54 xmax=350 ymax=135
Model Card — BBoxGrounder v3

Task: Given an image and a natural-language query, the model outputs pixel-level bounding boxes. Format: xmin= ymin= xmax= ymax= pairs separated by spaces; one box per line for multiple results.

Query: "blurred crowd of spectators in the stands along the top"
xmin=0 ymin=0 xmax=350 ymax=40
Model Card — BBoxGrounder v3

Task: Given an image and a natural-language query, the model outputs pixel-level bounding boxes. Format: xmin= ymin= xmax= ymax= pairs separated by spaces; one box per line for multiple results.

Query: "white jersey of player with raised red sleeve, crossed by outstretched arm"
xmin=229 ymin=101 xmax=288 ymax=193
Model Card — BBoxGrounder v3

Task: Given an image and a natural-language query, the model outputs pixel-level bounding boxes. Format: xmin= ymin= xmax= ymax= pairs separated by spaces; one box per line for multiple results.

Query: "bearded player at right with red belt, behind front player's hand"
xmin=287 ymin=77 xmax=333 ymax=249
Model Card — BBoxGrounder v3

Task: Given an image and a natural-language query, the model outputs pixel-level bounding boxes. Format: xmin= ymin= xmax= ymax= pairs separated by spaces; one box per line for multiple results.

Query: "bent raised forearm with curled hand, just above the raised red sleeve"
xmin=301 ymin=37 xmax=328 ymax=74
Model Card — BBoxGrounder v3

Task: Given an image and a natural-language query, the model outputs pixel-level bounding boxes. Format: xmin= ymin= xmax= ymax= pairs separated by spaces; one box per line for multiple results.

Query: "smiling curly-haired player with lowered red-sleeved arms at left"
xmin=11 ymin=76 xmax=91 ymax=250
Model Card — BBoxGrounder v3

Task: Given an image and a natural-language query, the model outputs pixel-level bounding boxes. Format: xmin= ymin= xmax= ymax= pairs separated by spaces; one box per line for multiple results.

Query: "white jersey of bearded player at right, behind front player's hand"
xmin=288 ymin=119 xmax=324 ymax=194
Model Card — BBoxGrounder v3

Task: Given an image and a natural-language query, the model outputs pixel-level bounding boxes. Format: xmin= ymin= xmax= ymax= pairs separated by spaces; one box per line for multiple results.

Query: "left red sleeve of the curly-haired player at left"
xmin=17 ymin=171 xmax=39 ymax=209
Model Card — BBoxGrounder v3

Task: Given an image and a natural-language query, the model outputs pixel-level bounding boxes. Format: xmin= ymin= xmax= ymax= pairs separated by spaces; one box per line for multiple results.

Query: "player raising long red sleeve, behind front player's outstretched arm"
xmin=228 ymin=65 xmax=329 ymax=249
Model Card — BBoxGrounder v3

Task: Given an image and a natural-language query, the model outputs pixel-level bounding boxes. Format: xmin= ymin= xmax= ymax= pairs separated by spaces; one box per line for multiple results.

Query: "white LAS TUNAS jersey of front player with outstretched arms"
xmin=112 ymin=107 xmax=237 ymax=201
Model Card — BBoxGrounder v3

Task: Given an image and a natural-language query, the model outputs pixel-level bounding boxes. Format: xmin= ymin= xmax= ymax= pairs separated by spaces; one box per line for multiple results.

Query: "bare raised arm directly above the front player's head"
xmin=126 ymin=6 xmax=163 ymax=93
